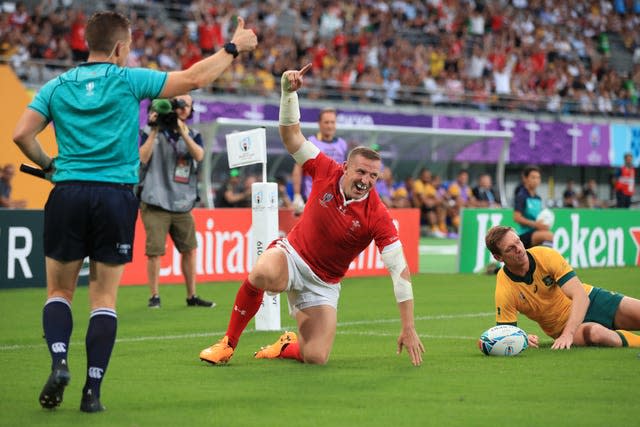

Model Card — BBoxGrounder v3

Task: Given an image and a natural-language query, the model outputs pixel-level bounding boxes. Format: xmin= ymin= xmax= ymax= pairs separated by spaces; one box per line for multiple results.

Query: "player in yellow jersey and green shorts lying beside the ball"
xmin=485 ymin=225 xmax=640 ymax=350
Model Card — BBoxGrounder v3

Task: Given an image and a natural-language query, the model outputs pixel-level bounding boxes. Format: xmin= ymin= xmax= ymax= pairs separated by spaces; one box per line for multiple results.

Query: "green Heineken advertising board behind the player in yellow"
xmin=458 ymin=209 xmax=640 ymax=273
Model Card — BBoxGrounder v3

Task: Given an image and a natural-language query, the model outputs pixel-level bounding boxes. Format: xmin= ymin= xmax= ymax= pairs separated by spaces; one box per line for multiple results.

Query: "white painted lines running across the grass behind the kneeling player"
xmin=0 ymin=311 xmax=494 ymax=351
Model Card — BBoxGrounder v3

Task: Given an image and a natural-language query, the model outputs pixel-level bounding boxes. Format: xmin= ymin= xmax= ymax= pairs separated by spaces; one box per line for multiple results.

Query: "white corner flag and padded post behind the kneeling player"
xmin=226 ymin=128 xmax=280 ymax=331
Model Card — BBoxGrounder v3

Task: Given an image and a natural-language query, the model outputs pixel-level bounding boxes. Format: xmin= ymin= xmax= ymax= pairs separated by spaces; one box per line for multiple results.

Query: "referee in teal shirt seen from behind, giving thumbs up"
xmin=13 ymin=12 xmax=257 ymax=412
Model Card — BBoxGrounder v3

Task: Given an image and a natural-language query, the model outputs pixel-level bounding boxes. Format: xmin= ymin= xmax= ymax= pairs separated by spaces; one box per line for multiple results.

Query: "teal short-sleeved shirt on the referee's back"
xmin=29 ymin=62 xmax=167 ymax=184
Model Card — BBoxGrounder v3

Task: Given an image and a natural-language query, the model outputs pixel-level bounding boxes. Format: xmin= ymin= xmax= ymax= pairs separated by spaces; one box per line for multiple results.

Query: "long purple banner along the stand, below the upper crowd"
xmin=186 ymin=100 xmax=640 ymax=166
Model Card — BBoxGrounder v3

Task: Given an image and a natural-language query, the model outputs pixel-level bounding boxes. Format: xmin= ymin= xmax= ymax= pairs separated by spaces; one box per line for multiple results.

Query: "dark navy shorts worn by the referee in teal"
xmin=44 ymin=181 xmax=138 ymax=264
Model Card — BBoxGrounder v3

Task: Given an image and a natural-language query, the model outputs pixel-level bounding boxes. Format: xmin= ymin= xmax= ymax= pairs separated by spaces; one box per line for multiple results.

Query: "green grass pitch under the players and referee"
xmin=0 ymin=268 xmax=640 ymax=427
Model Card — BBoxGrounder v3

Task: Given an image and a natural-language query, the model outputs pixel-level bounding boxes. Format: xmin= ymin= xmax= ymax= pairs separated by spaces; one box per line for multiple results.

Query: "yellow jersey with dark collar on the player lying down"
xmin=495 ymin=246 xmax=593 ymax=338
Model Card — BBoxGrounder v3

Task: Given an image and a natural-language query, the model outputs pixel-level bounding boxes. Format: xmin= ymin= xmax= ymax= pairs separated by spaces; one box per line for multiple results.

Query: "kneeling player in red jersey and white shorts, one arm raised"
xmin=200 ymin=64 xmax=424 ymax=365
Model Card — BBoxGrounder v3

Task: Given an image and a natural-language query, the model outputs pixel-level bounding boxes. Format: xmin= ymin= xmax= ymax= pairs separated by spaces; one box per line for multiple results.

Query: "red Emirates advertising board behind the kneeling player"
xmin=121 ymin=208 xmax=420 ymax=285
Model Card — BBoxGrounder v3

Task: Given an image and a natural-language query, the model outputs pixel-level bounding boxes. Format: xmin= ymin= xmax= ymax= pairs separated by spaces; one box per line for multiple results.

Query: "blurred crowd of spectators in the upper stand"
xmin=0 ymin=0 xmax=640 ymax=116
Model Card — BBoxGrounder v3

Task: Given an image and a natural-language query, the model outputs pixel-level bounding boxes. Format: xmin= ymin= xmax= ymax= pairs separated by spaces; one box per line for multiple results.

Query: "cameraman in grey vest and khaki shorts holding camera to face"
xmin=140 ymin=95 xmax=215 ymax=308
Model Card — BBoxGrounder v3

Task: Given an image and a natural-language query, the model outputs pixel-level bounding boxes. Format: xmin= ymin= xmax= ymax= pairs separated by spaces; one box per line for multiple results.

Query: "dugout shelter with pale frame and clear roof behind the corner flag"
xmin=200 ymin=117 xmax=513 ymax=207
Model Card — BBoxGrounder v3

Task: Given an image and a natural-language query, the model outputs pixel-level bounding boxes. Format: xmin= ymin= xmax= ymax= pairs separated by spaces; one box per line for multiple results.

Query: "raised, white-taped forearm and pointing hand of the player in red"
xmin=279 ymin=64 xmax=311 ymax=154
